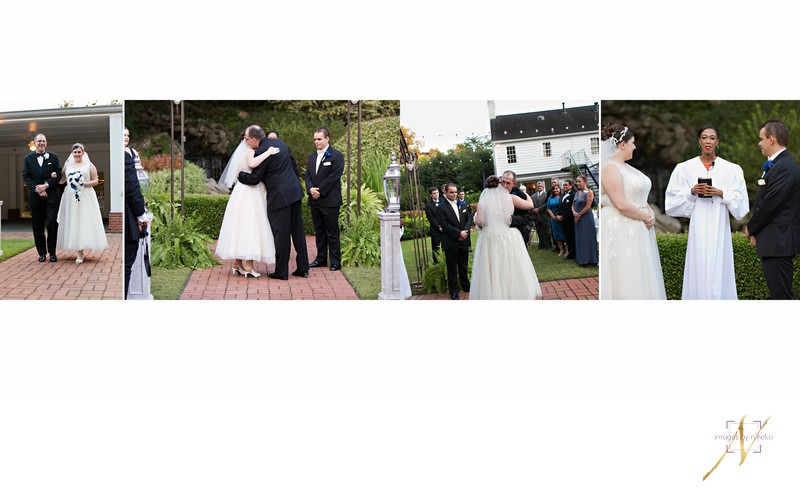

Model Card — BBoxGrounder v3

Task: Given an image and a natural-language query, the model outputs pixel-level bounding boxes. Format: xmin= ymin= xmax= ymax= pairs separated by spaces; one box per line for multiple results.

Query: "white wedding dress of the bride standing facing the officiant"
xmin=600 ymin=162 xmax=667 ymax=299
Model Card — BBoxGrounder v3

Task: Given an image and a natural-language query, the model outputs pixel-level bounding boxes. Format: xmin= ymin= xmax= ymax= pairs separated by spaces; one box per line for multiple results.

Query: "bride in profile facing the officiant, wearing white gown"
xmin=600 ymin=124 xmax=667 ymax=299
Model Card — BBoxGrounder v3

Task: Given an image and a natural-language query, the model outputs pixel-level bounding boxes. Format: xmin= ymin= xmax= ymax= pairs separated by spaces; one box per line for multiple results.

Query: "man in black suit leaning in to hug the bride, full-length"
xmin=239 ymin=125 xmax=308 ymax=280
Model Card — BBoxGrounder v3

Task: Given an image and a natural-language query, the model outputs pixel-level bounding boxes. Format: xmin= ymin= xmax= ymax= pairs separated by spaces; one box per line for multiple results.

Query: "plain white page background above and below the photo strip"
xmin=0 ymin=1 xmax=800 ymax=497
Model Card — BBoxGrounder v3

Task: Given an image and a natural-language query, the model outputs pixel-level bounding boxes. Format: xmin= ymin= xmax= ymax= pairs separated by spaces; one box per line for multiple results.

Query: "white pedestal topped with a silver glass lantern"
xmin=378 ymin=154 xmax=405 ymax=301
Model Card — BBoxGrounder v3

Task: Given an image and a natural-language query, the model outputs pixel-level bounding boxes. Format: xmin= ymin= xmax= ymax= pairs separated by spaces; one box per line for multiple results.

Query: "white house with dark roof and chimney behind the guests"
xmin=488 ymin=100 xmax=600 ymax=188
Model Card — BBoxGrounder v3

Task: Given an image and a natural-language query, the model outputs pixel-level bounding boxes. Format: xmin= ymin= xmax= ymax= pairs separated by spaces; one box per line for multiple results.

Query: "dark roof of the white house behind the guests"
xmin=490 ymin=104 xmax=600 ymax=142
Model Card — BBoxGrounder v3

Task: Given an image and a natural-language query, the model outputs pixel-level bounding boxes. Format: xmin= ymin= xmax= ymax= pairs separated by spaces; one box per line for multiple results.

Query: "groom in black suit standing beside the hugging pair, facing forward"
xmin=306 ymin=128 xmax=344 ymax=271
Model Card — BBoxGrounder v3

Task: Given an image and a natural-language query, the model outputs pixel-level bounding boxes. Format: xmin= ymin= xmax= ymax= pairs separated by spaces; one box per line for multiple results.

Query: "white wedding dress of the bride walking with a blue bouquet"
xmin=56 ymin=153 xmax=108 ymax=251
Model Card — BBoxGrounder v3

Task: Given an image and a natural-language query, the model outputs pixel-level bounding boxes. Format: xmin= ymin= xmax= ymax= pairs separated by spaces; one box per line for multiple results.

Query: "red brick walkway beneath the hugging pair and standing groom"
xmin=180 ymin=235 xmax=358 ymax=300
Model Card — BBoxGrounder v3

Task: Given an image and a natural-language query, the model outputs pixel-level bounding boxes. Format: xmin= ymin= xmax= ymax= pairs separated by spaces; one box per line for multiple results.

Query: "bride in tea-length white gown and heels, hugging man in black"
xmin=214 ymin=140 xmax=280 ymax=278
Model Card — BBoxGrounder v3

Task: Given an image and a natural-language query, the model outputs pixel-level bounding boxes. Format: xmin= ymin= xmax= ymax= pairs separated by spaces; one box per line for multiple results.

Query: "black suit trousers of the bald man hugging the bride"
xmin=267 ymin=201 xmax=308 ymax=278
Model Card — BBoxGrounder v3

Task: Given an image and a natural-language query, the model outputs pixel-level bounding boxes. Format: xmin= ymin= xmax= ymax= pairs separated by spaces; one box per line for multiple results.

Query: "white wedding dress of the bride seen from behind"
xmin=469 ymin=187 xmax=542 ymax=300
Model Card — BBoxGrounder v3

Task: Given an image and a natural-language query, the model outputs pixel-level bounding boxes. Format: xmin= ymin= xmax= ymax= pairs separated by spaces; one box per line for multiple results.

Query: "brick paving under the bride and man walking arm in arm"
xmin=0 ymin=232 xmax=124 ymax=300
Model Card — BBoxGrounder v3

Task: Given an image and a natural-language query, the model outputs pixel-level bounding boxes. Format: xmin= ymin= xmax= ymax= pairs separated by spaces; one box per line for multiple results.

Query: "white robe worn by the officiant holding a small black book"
xmin=665 ymin=154 xmax=750 ymax=299
